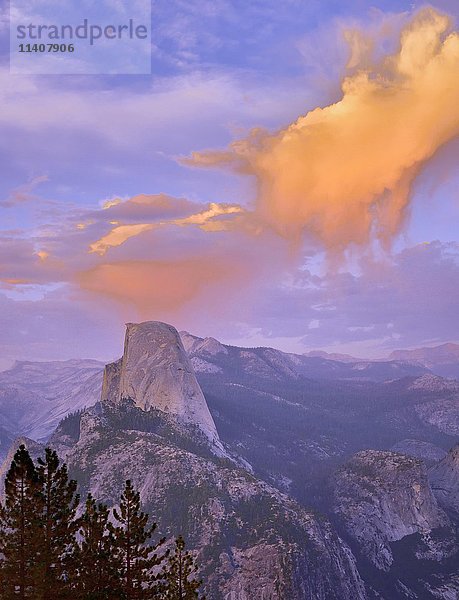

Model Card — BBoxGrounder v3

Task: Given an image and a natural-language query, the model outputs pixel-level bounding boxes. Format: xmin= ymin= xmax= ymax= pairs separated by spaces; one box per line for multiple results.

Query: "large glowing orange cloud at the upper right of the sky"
xmin=184 ymin=8 xmax=459 ymax=251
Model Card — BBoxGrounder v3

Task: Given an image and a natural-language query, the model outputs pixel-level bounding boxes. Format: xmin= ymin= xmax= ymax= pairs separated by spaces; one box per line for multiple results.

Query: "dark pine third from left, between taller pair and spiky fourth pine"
xmin=71 ymin=494 xmax=122 ymax=600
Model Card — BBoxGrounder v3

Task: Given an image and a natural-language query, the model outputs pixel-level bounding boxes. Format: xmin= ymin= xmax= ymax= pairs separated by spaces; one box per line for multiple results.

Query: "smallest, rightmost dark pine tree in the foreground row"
xmin=160 ymin=536 xmax=204 ymax=600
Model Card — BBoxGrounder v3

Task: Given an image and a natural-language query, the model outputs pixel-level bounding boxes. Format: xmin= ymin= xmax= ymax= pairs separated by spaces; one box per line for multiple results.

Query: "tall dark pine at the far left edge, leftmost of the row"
xmin=0 ymin=445 xmax=43 ymax=600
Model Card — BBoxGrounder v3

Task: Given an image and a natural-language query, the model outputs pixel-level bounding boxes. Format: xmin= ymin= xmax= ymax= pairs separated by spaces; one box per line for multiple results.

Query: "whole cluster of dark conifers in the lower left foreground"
xmin=0 ymin=452 xmax=204 ymax=600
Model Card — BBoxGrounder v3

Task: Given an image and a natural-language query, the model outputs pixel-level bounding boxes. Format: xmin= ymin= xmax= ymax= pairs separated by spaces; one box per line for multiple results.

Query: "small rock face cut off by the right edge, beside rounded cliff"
xmin=429 ymin=444 xmax=459 ymax=514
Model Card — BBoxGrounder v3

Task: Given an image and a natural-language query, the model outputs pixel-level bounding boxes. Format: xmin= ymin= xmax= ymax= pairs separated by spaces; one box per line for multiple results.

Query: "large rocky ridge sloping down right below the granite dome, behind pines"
xmin=63 ymin=405 xmax=367 ymax=600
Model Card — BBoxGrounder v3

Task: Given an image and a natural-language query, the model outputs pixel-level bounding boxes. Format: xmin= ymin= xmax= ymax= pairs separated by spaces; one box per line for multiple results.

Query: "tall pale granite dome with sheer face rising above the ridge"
xmin=102 ymin=321 xmax=222 ymax=450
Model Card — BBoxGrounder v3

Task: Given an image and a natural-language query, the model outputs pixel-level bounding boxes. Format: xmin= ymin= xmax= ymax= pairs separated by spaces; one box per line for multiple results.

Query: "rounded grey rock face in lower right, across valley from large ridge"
xmin=333 ymin=450 xmax=449 ymax=570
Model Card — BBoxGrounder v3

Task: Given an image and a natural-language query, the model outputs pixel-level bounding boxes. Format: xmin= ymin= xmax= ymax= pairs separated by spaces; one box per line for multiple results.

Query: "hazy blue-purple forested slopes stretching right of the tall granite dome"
xmin=181 ymin=332 xmax=459 ymax=503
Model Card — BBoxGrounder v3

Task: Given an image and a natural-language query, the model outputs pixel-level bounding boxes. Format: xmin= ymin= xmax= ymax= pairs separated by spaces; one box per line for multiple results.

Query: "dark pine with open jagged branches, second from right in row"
xmin=111 ymin=480 xmax=165 ymax=600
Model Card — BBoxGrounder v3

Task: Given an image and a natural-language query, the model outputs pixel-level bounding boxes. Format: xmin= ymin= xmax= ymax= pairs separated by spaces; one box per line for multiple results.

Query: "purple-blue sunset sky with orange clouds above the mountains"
xmin=0 ymin=0 xmax=459 ymax=368
